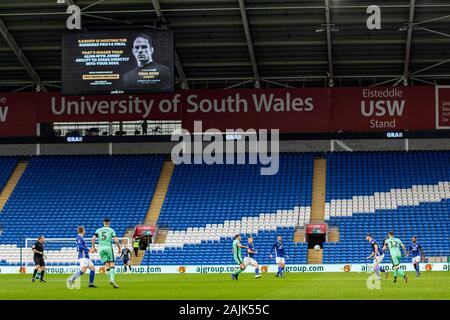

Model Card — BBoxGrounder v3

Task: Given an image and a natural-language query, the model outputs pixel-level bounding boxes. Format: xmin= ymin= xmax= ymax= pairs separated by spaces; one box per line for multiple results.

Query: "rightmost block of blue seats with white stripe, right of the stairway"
xmin=324 ymin=152 xmax=450 ymax=263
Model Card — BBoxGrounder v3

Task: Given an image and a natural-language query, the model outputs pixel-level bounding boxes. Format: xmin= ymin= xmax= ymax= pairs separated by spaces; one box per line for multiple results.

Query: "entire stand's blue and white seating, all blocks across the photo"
xmin=0 ymin=151 xmax=450 ymax=265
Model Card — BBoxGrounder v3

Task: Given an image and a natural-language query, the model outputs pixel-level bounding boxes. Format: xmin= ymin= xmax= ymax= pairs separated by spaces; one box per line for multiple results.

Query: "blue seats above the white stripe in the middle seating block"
xmin=158 ymin=154 xmax=313 ymax=230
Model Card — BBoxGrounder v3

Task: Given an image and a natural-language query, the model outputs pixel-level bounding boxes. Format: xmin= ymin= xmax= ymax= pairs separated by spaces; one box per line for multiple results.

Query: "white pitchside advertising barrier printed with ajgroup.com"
xmin=0 ymin=262 xmax=450 ymax=275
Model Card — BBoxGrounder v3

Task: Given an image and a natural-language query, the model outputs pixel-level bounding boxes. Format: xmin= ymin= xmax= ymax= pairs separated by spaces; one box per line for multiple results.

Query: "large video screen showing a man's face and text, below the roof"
xmin=61 ymin=30 xmax=174 ymax=95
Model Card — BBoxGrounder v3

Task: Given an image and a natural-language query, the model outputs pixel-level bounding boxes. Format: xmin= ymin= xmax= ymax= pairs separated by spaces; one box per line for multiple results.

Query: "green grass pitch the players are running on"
xmin=0 ymin=272 xmax=450 ymax=300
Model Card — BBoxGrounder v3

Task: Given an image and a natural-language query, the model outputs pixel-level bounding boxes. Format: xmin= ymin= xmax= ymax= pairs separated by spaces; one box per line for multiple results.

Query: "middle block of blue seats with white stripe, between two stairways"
xmin=143 ymin=154 xmax=313 ymax=264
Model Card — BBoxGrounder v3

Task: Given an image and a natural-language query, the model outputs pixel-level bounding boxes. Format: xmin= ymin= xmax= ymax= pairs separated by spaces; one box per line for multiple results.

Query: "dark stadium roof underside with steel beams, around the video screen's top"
xmin=0 ymin=0 xmax=450 ymax=91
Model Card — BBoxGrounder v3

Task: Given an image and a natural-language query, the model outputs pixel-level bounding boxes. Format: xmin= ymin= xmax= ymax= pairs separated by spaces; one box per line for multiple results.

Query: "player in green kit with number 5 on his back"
xmin=92 ymin=218 xmax=122 ymax=289
